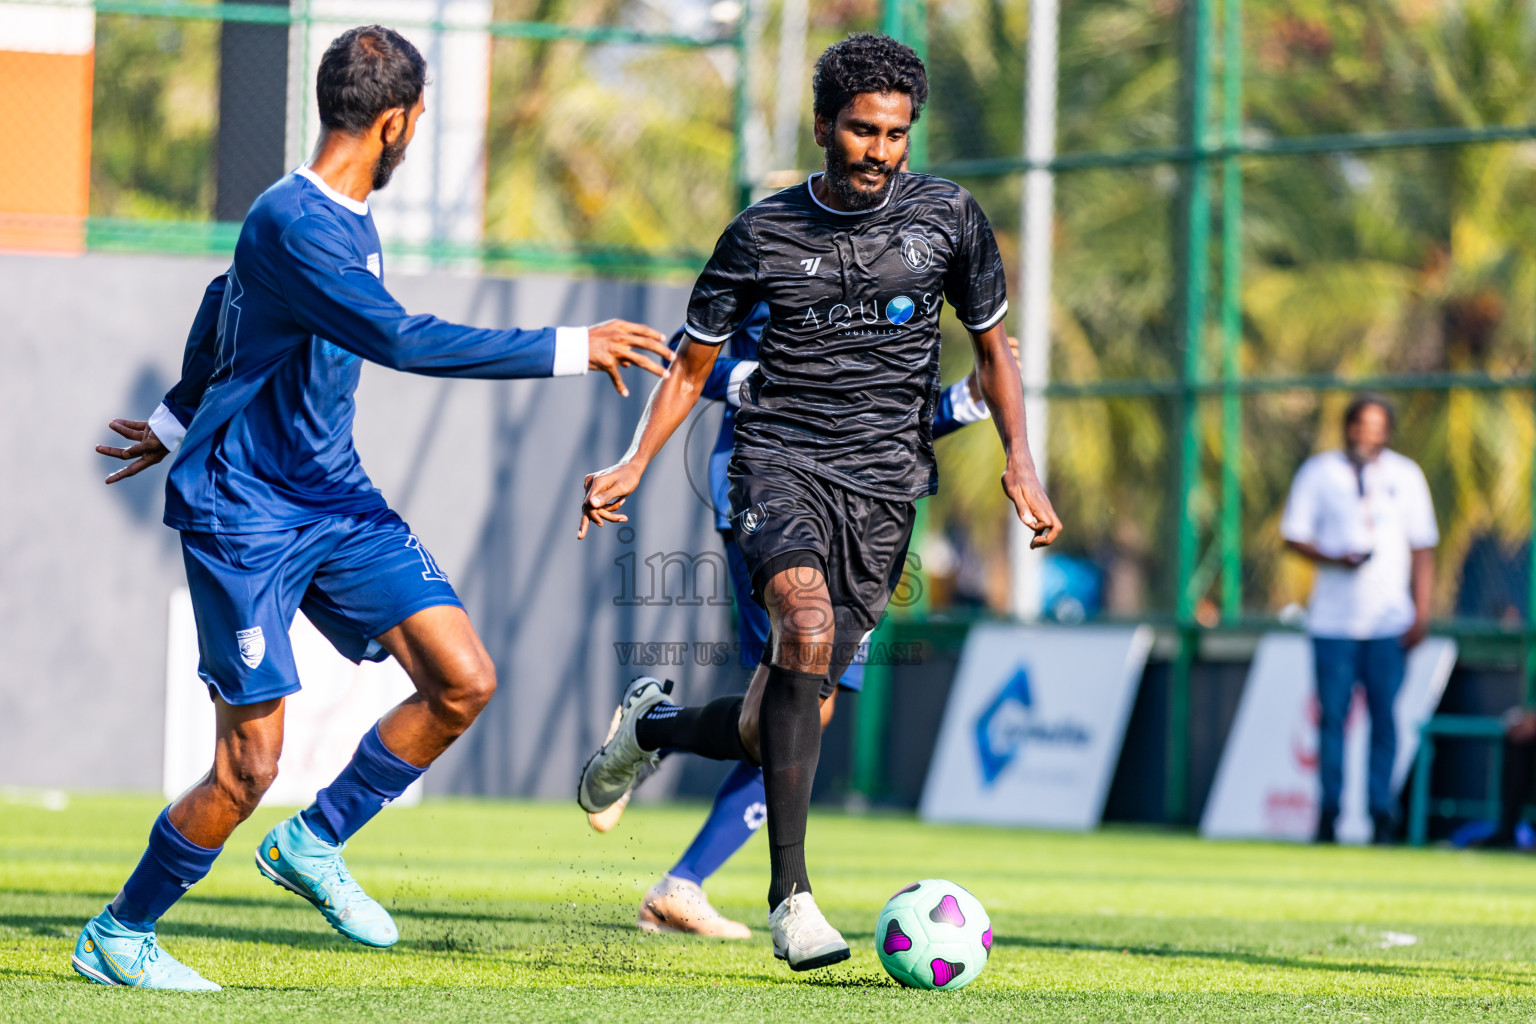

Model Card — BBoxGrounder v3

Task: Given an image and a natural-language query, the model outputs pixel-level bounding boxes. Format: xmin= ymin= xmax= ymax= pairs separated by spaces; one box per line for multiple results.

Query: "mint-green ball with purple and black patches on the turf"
xmin=874 ymin=878 xmax=992 ymax=992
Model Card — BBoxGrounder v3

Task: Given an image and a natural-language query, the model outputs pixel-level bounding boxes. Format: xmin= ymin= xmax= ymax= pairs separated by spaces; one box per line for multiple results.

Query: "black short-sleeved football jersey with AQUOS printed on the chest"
xmin=685 ymin=173 xmax=1008 ymax=500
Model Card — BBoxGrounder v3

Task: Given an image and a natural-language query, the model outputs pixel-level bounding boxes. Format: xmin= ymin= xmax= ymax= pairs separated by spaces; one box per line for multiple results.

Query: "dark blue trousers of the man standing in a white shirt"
xmin=1312 ymin=637 xmax=1407 ymax=818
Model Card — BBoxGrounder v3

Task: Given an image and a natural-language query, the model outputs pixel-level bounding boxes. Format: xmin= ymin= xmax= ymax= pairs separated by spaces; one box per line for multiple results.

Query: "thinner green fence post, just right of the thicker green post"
xmin=1221 ymin=0 xmax=1243 ymax=619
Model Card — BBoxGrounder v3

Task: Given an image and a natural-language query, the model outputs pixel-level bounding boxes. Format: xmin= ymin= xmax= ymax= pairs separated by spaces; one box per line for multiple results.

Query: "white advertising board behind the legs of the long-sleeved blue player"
xmin=161 ymin=588 xmax=421 ymax=806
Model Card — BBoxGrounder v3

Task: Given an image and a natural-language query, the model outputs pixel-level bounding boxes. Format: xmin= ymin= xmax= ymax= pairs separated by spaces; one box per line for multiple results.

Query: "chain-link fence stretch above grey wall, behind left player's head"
xmin=0 ymin=0 xmax=742 ymax=275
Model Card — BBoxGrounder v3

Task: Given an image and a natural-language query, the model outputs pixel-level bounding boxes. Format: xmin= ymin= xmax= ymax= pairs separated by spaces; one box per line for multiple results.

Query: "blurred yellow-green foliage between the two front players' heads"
xmin=485 ymin=0 xmax=736 ymax=252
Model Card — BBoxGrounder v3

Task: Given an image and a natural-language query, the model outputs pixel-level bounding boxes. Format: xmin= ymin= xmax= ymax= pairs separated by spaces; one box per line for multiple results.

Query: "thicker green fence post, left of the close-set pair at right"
xmin=1164 ymin=0 xmax=1212 ymax=823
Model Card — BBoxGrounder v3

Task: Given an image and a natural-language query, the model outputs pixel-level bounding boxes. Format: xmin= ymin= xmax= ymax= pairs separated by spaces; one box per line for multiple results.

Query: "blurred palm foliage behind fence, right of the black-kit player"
xmin=932 ymin=0 xmax=1536 ymax=614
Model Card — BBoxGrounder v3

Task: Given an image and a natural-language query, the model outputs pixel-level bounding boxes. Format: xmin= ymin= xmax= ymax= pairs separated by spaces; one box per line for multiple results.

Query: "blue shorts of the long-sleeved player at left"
xmin=181 ymin=508 xmax=462 ymax=705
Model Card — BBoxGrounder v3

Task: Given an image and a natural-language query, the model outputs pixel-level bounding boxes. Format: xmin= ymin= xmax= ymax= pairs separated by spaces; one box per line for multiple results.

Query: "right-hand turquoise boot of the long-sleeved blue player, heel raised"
xmin=257 ymin=814 xmax=399 ymax=949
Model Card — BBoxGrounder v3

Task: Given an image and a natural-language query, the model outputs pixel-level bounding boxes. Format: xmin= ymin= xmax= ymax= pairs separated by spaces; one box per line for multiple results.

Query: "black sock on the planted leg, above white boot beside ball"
xmin=757 ymin=666 xmax=826 ymax=910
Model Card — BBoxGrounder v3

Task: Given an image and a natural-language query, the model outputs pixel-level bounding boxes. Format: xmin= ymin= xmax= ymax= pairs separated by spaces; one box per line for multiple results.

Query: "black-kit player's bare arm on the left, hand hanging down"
xmin=576 ymin=338 xmax=720 ymax=540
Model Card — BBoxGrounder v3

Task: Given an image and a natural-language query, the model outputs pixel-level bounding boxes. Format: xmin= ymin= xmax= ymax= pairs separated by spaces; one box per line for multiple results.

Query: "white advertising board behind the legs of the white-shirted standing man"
xmin=1200 ymin=633 xmax=1456 ymax=843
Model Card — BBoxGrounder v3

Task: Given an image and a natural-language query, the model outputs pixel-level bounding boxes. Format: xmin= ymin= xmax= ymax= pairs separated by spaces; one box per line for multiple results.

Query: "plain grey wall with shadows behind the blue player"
xmin=0 ymin=255 xmax=742 ymax=797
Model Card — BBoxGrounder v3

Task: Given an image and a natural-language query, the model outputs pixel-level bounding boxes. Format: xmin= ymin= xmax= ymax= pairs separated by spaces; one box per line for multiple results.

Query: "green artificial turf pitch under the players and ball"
xmin=0 ymin=795 xmax=1536 ymax=1024
